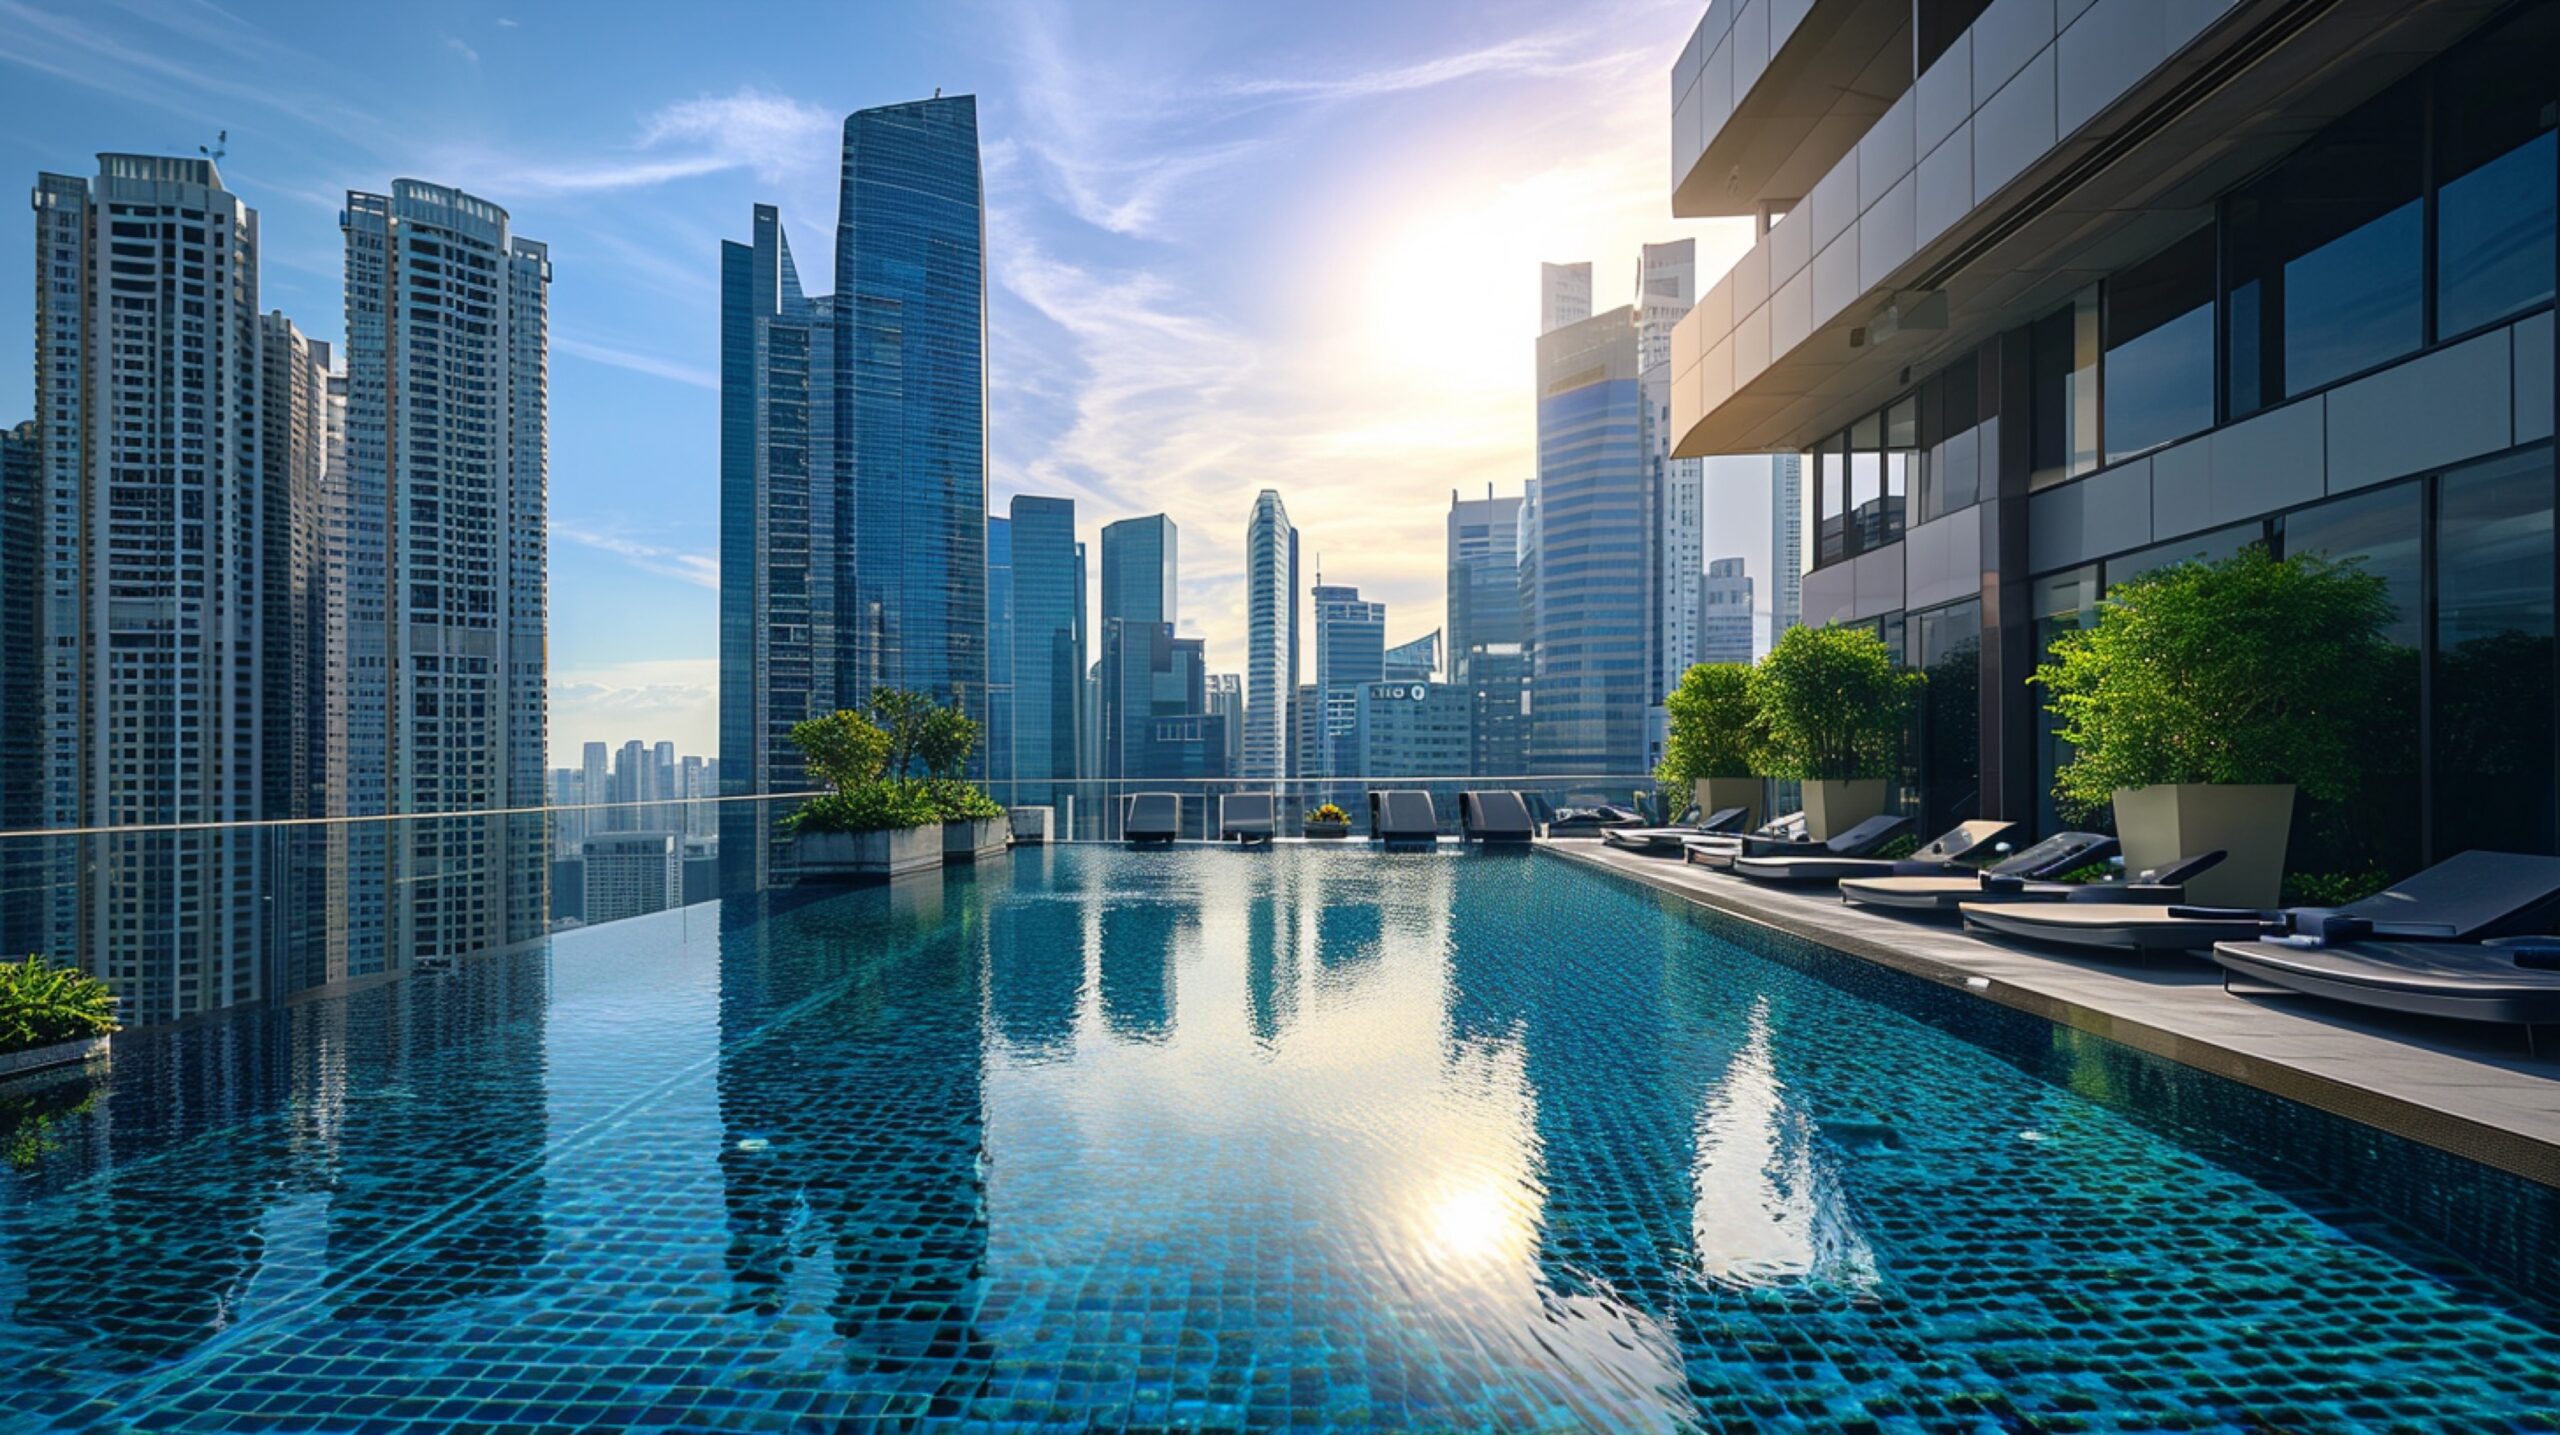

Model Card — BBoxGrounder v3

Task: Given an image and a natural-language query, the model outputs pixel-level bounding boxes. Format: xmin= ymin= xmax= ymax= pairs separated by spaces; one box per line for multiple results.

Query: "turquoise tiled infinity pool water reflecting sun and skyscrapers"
xmin=0 ymin=847 xmax=2560 ymax=1430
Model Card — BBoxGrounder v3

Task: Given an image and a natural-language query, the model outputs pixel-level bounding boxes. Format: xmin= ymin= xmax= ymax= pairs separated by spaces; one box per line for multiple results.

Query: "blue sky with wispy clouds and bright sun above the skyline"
xmin=0 ymin=0 xmax=1759 ymax=755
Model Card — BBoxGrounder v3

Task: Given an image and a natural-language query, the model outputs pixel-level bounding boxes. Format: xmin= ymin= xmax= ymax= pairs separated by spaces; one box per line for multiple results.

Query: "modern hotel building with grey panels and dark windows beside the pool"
xmin=1672 ymin=0 xmax=2560 ymax=854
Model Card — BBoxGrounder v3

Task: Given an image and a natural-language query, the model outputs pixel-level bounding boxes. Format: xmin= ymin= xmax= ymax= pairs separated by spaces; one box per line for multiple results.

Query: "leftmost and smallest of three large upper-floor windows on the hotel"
xmin=2104 ymin=225 xmax=2214 ymax=463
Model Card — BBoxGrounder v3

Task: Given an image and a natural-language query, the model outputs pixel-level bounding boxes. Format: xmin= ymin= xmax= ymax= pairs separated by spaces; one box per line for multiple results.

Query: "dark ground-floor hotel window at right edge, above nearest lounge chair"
xmin=2432 ymin=448 xmax=2560 ymax=859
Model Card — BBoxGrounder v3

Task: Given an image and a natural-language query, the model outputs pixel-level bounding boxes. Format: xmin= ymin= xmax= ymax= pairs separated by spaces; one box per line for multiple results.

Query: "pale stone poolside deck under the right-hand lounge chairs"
xmin=1539 ymin=839 xmax=2560 ymax=1187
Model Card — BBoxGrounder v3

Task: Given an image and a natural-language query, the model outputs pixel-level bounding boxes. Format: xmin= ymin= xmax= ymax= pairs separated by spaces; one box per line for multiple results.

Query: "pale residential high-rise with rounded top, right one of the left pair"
xmin=340 ymin=179 xmax=550 ymax=969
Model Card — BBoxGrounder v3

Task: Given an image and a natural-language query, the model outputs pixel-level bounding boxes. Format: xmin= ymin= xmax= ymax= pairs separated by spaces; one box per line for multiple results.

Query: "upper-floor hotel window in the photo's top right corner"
xmin=2435 ymin=5 xmax=2560 ymax=338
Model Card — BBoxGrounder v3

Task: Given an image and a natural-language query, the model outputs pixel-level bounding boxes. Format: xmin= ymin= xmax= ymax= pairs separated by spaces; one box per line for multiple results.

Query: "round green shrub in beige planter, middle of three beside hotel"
xmin=1748 ymin=627 xmax=1925 ymax=842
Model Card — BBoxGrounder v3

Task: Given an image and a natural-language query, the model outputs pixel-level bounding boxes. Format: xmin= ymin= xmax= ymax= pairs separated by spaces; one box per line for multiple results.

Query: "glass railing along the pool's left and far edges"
xmin=0 ymin=775 xmax=1661 ymax=1026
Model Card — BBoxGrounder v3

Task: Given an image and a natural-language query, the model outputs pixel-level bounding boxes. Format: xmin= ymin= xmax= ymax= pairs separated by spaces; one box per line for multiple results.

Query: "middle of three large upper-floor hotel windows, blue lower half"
xmin=2225 ymin=77 xmax=2424 ymax=417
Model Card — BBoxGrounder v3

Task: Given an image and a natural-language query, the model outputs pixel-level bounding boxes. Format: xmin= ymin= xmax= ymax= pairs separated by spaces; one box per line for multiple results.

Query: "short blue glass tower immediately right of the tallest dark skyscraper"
xmin=998 ymin=494 xmax=1085 ymax=821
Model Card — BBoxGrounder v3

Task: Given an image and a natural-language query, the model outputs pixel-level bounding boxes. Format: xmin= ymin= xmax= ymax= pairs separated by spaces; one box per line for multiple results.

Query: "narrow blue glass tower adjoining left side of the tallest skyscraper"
xmin=711 ymin=205 xmax=829 ymax=893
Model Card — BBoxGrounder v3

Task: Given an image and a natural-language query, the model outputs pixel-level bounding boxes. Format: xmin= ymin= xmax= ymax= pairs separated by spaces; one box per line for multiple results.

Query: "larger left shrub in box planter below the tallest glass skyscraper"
xmin=783 ymin=709 xmax=942 ymax=880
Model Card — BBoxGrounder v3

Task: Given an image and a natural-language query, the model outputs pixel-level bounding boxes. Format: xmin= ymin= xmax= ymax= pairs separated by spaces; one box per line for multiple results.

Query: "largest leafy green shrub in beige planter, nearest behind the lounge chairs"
xmin=2030 ymin=547 xmax=2385 ymax=908
